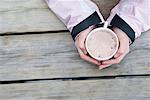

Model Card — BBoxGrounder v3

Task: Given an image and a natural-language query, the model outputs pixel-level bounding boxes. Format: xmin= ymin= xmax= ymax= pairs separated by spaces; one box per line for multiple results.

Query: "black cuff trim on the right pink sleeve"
xmin=110 ymin=14 xmax=135 ymax=43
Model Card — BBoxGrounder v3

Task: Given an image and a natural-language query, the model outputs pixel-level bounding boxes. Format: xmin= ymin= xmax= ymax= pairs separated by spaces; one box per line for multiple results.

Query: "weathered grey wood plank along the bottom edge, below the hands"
xmin=0 ymin=78 xmax=150 ymax=100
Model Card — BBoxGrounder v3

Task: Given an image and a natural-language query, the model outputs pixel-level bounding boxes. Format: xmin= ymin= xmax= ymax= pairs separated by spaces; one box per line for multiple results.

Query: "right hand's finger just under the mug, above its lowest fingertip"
xmin=102 ymin=54 xmax=126 ymax=65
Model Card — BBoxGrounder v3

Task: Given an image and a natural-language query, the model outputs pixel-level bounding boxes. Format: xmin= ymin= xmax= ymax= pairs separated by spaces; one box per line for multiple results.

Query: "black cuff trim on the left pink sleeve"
xmin=71 ymin=11 xmax=101 ymax=40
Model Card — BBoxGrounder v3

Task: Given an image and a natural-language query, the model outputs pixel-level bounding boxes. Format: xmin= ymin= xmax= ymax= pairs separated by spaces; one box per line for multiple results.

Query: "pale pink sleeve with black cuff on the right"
xmin=107 ymin=0 xmax=150 ymax=42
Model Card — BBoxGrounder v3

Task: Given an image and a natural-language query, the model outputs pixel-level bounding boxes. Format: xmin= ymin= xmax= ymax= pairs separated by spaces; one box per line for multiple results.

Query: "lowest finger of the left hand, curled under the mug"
xmin=77 ymin=48 xmax=100 ymax=66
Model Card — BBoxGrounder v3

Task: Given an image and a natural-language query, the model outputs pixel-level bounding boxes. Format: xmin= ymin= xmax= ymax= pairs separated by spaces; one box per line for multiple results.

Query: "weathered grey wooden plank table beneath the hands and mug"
xmin=0 ymin=0 xmax=150 ymax=100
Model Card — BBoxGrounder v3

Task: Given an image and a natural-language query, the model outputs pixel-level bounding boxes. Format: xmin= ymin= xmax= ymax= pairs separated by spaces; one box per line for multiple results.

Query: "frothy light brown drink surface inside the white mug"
xmin=87 ymin=30 xmax=117 ymax=59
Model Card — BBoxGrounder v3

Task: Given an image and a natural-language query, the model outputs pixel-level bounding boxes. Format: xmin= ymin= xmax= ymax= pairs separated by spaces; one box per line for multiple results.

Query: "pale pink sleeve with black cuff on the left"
xmin=45 ymin=0 xmax=104 ymax=39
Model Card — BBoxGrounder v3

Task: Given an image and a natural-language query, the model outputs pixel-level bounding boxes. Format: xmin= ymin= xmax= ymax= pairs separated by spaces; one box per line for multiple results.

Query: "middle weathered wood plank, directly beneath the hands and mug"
xmin=0 ymin=32 xmax=150 ymax=81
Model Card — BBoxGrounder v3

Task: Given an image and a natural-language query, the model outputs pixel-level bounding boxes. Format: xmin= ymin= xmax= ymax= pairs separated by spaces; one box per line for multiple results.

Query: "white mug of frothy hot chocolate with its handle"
xmin=85 ymin=23 xmax=119 ymax=61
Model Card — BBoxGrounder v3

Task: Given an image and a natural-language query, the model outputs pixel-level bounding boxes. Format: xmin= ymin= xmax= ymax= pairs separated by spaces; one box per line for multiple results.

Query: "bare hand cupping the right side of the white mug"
xmin=99 ymin=28 xmax=130 ymax=69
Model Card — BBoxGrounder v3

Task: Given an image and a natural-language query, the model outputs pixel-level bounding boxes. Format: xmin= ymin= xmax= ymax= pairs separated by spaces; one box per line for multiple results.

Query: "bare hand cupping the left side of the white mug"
xmin=75 ymin=26 xmax=100 ymax=66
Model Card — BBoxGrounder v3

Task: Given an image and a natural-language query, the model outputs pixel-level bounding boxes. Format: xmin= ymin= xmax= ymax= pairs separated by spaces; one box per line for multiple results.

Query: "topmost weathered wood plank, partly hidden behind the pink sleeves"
xmin=0 ymin=0 xmax=117 ymax=34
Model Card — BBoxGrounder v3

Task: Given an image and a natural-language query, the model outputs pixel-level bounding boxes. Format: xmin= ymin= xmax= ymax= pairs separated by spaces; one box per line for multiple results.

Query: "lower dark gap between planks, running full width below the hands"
xmin=0 ymin=74 xmax=150 ymax=85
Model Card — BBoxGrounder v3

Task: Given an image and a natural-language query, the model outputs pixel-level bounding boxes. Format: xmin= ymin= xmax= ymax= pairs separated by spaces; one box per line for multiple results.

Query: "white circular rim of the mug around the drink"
xmin=85 ymin=27 xmax=119 ymax=61
